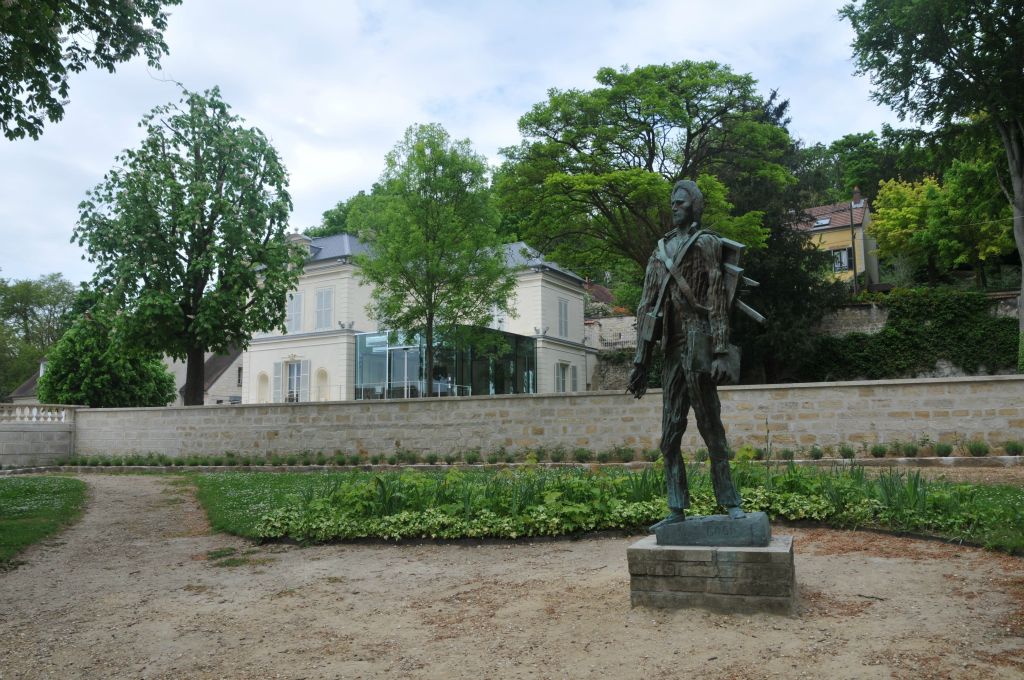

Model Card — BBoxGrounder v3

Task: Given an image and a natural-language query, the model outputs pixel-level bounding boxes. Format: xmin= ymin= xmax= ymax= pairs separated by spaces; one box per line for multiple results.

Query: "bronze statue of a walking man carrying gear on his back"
xmin=628 ymin=180 xmax=756 ymax=529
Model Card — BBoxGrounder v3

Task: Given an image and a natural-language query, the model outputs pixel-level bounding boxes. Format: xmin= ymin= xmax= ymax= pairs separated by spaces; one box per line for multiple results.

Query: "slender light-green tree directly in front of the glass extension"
xmin=347 ymin=120 xmax=515 ymax=381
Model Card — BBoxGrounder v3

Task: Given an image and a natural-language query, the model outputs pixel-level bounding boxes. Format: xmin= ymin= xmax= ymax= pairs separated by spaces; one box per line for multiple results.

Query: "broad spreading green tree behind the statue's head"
xmin=496 ymin=61 xmax=796 ymax=271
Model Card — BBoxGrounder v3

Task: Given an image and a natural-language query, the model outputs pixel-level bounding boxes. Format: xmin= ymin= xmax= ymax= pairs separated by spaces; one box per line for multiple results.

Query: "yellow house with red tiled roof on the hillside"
xmin=796 ymin=188 xmax=879 ymax=285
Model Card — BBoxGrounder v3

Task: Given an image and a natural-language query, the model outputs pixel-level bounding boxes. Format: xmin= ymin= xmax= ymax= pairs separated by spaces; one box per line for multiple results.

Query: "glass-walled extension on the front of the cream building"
xmin=355 ymin=329 xmax=537 ymax=399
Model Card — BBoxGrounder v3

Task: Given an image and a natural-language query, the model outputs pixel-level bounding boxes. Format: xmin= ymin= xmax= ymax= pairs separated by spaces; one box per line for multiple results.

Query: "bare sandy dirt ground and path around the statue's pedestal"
xmin=0 ymin=474 xmax=1024 ymax=679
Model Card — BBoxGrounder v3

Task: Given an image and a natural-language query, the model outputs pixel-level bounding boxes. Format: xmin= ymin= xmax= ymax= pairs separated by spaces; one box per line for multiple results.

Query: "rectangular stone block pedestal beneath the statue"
xmin=627 ymin=536 xmax=796 ymax=614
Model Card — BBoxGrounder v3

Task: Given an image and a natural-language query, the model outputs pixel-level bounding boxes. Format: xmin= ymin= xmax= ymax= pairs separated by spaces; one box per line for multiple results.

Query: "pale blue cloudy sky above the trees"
xmin=0 ymin=0 xmax=897 ymax=283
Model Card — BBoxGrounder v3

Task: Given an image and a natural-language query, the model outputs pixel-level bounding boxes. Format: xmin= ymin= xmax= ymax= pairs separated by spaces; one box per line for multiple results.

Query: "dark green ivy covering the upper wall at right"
xmin=801 ymin=288 xmax=1018 ymax=381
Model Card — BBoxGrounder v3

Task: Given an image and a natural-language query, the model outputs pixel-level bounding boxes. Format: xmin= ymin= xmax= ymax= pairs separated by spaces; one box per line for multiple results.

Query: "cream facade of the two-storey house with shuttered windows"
xmin=243 ymin=235 xmax=596 ymax=403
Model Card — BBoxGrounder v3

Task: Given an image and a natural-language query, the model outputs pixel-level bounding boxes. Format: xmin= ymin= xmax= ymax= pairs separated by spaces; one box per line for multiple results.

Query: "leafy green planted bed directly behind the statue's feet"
xmin=196 ymin=462 xmax=1024 ymax=552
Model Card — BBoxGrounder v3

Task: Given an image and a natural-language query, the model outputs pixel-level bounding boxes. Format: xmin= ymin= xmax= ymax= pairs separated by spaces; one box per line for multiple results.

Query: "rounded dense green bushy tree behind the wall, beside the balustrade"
xmin=36 ymin=304 xmax=174 ymax=409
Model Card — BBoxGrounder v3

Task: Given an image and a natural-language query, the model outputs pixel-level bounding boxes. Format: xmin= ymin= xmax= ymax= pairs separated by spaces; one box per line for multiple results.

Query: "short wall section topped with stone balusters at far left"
xmin=0 ymin=405 xmax=76 ymax=468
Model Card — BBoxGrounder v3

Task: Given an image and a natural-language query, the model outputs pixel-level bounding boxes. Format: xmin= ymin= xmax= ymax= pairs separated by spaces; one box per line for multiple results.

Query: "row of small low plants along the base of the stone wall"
xmin=28 ymin=438 xmax=1024 ymax=467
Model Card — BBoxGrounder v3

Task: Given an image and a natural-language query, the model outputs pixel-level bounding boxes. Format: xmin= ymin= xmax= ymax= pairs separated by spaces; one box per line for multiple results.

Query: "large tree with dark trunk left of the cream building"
xmin=74 ymin=88 xmax=304 ymax=405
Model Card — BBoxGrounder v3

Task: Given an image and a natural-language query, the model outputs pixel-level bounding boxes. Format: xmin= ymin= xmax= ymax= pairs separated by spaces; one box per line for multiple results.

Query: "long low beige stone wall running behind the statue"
xmin=75 ymin=376 xmax=1024 ymax=456
